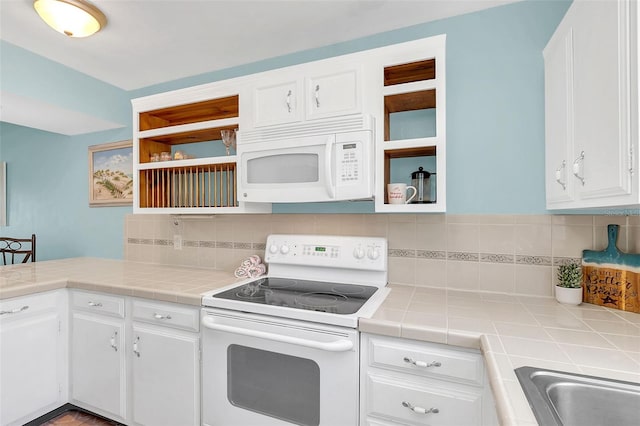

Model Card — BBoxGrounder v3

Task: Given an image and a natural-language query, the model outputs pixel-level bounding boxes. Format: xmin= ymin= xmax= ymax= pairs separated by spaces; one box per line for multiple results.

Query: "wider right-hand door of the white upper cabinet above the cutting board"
xmin=569 ymin=0 xmax=632 ymax=200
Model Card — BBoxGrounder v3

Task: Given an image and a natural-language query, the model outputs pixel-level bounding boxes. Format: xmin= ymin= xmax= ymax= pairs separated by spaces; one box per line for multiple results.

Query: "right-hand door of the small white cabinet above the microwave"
xmin=305 ymin=69 xmax=360 ymax=119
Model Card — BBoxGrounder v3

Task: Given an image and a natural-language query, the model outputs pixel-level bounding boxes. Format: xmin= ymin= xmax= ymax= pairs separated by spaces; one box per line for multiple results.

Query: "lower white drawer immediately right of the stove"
xmin=365 ymin=374 xmax=482 ymax=426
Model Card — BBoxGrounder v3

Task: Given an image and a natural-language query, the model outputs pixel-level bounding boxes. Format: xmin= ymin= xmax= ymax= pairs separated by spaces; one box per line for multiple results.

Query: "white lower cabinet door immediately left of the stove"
xmin=132 ymin=324 xmax=200 ymax=426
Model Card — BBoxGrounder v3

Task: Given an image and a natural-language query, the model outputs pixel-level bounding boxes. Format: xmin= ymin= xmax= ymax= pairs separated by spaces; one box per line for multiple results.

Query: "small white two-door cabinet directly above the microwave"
xmin=252 ymin=62 xmax=362 ymax=127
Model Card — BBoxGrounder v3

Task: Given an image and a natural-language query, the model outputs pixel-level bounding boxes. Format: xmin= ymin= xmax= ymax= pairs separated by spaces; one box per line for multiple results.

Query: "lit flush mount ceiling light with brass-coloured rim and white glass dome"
xmin=33 ymin=0 xmax=107 ymax=37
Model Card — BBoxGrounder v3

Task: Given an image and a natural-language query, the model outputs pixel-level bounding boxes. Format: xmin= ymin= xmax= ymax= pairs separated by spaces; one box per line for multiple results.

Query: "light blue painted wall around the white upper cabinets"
xmin=0 ymin=0 xmax=569 ymax=260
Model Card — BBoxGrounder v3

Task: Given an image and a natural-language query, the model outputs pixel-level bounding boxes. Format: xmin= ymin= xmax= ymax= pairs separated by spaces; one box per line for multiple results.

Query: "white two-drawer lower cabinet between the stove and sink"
xmin=360 ymin=334 xmax=497 ymax=426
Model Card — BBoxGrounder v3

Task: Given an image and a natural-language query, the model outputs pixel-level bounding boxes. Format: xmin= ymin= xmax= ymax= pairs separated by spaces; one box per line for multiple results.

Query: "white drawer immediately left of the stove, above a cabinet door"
xmin=133 ymin=300 xmax=200 ymax=331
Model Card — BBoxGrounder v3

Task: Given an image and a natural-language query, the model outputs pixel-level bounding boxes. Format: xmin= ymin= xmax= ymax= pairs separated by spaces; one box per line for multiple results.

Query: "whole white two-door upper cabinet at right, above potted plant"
xmin=544 ymin=0 xmax=640 ymax=209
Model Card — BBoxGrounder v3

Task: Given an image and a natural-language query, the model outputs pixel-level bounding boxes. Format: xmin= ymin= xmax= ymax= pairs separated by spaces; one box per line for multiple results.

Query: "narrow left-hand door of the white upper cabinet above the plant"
xmin=544 ymin=22 xmax=575 ymax=207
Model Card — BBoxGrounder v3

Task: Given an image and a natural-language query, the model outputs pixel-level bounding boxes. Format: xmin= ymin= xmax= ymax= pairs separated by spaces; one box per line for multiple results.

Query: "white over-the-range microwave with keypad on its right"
xmin=238 ymin=115 xmax=374 ymax=203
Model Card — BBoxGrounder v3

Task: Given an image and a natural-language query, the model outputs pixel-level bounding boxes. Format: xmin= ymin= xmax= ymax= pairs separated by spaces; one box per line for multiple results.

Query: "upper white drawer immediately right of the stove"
xmin=368 ymin=338 xmax=483 ymax=385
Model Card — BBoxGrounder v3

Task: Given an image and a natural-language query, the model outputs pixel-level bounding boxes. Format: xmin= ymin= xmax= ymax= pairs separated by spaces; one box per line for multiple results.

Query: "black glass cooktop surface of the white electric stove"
xmin=213 ymin=277 xmax=377 ymax=315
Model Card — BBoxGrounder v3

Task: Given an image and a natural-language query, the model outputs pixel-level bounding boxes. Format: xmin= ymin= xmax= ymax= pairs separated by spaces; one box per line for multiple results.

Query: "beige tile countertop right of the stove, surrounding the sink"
xmin=358 ymin=285 xmax=640 ymax=426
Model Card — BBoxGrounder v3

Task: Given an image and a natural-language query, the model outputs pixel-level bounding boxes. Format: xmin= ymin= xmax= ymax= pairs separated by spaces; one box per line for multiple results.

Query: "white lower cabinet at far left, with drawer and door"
xmin=0 ymin=290 xmax=67 ymax=426
